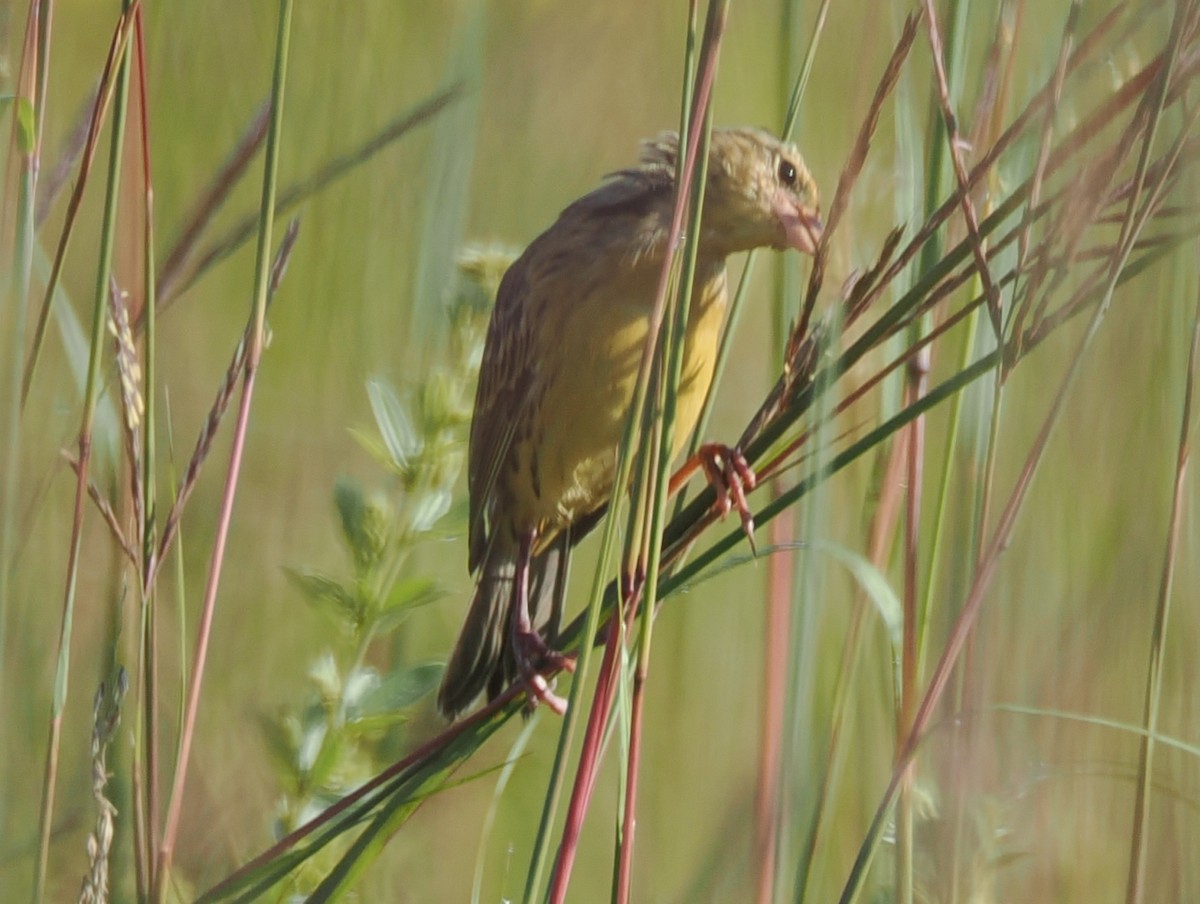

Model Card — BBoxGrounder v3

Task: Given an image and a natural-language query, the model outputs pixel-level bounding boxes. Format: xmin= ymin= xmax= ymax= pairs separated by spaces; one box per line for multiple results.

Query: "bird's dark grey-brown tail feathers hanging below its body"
xmin=438 ymin=531 xmax=570 ymax=719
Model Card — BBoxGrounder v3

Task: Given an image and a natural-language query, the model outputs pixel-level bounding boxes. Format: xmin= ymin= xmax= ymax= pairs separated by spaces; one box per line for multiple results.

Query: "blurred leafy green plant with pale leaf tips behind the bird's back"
xmin=265 ymin=247 xmax=511 ymax=896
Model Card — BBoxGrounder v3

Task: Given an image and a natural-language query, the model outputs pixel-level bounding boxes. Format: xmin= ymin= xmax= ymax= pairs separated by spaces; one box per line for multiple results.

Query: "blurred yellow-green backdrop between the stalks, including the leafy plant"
xmin=0 ymin=0 xmax=1200 ymax=903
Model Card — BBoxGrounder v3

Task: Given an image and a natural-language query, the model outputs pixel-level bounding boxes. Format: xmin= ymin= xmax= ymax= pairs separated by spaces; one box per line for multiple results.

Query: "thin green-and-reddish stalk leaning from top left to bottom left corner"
xmin=32 ymin=0 xmax=136 ymax=902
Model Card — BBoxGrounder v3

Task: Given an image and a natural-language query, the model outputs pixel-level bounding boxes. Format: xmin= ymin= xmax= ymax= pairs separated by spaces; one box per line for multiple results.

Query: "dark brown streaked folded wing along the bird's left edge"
xmin=467 ymin=257 xmax=534 ymax=573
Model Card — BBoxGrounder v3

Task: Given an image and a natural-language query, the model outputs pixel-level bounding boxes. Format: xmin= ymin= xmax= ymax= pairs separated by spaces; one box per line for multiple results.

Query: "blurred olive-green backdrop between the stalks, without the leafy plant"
xmin=0 ymin=0 xmax=1200 ymax=902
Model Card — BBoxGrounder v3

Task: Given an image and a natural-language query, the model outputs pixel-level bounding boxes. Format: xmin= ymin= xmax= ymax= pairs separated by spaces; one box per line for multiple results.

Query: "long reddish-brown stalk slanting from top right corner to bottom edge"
xmin=840 ymin=19 xmax=1190 ymax=904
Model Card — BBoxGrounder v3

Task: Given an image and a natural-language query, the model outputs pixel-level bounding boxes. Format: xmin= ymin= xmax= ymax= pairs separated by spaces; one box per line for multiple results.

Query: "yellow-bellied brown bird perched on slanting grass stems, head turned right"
xmin=438 ymin=128 xmax=821 ymax=718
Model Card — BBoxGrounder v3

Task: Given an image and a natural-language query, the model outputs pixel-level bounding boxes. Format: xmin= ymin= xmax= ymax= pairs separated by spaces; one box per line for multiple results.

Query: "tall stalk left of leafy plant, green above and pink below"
xmin=152 ymin=0 xmax=292 ymax=904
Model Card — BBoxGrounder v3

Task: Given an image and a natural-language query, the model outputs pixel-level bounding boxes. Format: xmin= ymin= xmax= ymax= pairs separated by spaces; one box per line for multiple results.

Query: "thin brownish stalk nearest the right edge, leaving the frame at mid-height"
xmin=1126 ymin=248 xmax=1200 ymax=904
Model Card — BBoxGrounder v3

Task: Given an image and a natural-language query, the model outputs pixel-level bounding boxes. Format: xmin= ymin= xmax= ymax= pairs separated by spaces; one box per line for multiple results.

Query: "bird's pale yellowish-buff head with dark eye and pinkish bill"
xmin=642 ymin=128 xmax=822 ymax=255
